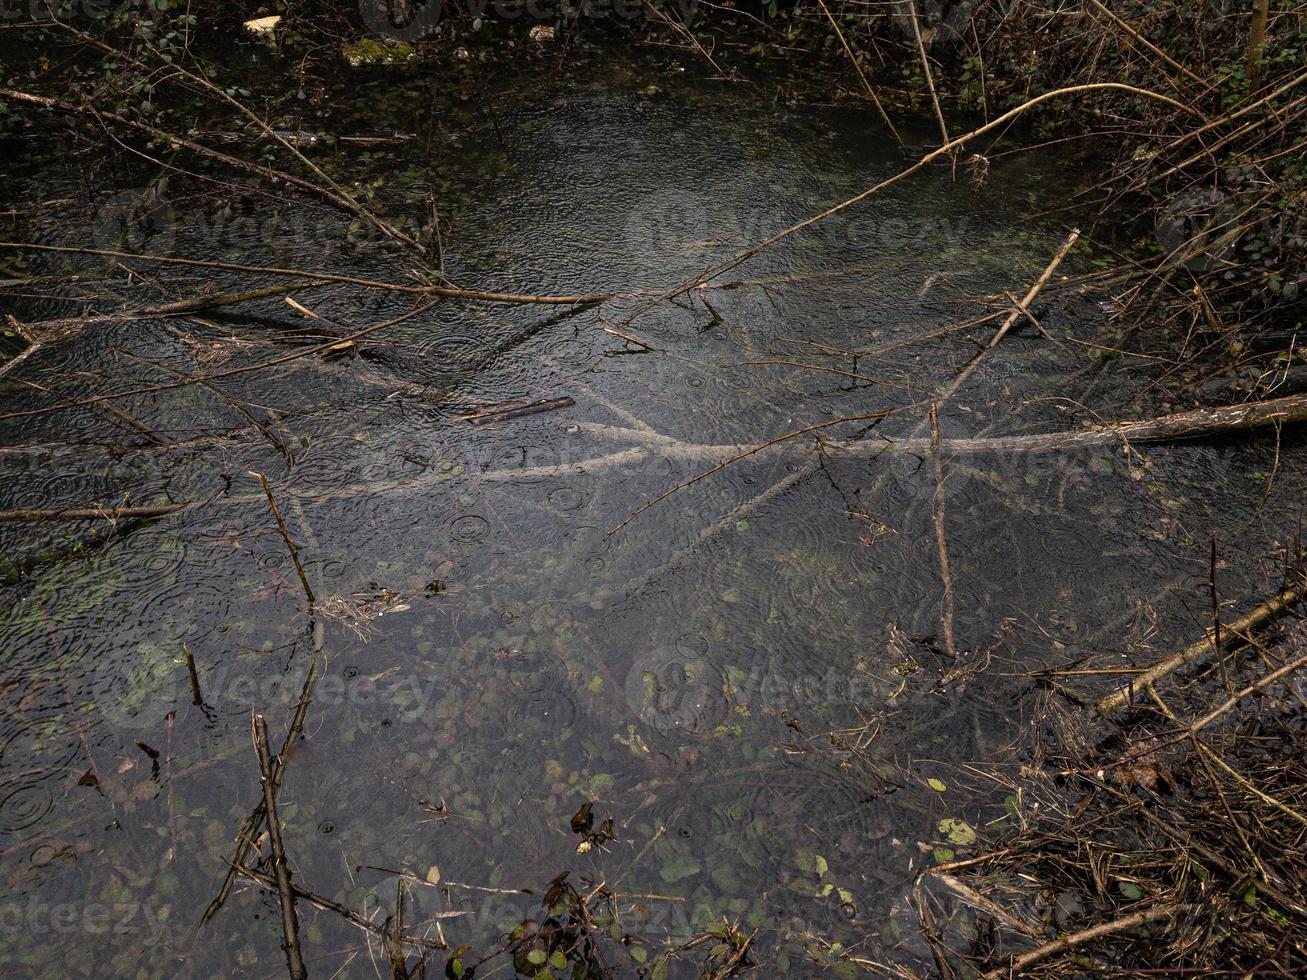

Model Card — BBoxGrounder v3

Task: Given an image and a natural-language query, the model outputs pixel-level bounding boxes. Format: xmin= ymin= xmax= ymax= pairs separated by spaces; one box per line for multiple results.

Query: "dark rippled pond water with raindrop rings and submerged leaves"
xmin=0 ymin=51 xmax=1300 ymax=976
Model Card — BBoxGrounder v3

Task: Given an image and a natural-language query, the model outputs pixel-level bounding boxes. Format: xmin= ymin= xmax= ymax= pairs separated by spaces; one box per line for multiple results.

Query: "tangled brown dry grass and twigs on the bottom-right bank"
xmin=916 ymin=622 xmax=1307 ymax=976
